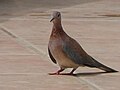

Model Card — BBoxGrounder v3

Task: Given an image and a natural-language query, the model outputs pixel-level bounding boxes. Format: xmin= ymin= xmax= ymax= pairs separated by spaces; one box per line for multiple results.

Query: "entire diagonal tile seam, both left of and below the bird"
xmin=0 ymin=26 xmax=103 ymax=90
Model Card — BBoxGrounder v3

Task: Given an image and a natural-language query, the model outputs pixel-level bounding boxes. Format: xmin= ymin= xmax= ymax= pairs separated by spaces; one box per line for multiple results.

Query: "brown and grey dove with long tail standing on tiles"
xmin=48 ymin=11 xmax=118 ymax=75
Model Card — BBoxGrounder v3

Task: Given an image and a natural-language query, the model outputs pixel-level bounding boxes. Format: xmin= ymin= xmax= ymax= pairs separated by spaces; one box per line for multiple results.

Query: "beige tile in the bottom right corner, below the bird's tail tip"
xmin=84 ymin=73 xmax=120 ymax=90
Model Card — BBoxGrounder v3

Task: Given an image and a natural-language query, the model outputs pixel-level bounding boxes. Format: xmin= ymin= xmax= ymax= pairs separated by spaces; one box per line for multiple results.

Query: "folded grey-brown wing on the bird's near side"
xmin=63 ymin=39 xmax=96 ymax=67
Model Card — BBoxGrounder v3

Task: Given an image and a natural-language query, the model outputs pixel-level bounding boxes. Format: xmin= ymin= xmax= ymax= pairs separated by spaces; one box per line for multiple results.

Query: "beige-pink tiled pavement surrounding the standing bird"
xmin=0 ymin=0 xmax=120 ymax=90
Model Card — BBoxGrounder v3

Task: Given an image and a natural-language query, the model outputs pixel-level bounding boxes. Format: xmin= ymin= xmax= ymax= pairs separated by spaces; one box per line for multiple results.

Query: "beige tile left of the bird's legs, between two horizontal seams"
xmin=0 ymin=55 xmax=52 ymax=74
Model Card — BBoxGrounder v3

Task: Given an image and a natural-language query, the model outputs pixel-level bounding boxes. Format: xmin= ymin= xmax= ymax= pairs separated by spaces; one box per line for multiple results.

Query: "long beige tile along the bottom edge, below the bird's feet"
xmin=0 ymin=74 xmax=90 ymax=90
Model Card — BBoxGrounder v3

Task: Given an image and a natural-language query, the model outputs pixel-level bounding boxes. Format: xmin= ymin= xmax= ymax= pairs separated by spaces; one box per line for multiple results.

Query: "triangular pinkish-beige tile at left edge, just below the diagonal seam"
xmin=0 ymin=29 xmax=34 ymax=55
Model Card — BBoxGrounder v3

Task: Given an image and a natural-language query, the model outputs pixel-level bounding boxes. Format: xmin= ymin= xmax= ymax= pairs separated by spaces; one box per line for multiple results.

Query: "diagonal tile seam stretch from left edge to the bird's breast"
xmin=0 ymin=26 xmax=48 ymax=59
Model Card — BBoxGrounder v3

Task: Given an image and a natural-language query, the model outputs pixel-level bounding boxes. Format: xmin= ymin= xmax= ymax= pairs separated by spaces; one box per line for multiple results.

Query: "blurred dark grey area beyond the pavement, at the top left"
xmin=0 ymin=0 xmax=99 ymax=22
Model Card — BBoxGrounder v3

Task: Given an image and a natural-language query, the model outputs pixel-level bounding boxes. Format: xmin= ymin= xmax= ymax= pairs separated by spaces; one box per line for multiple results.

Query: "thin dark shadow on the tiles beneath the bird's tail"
xmin=73 ymin=72 xmax=112 ymax=77
